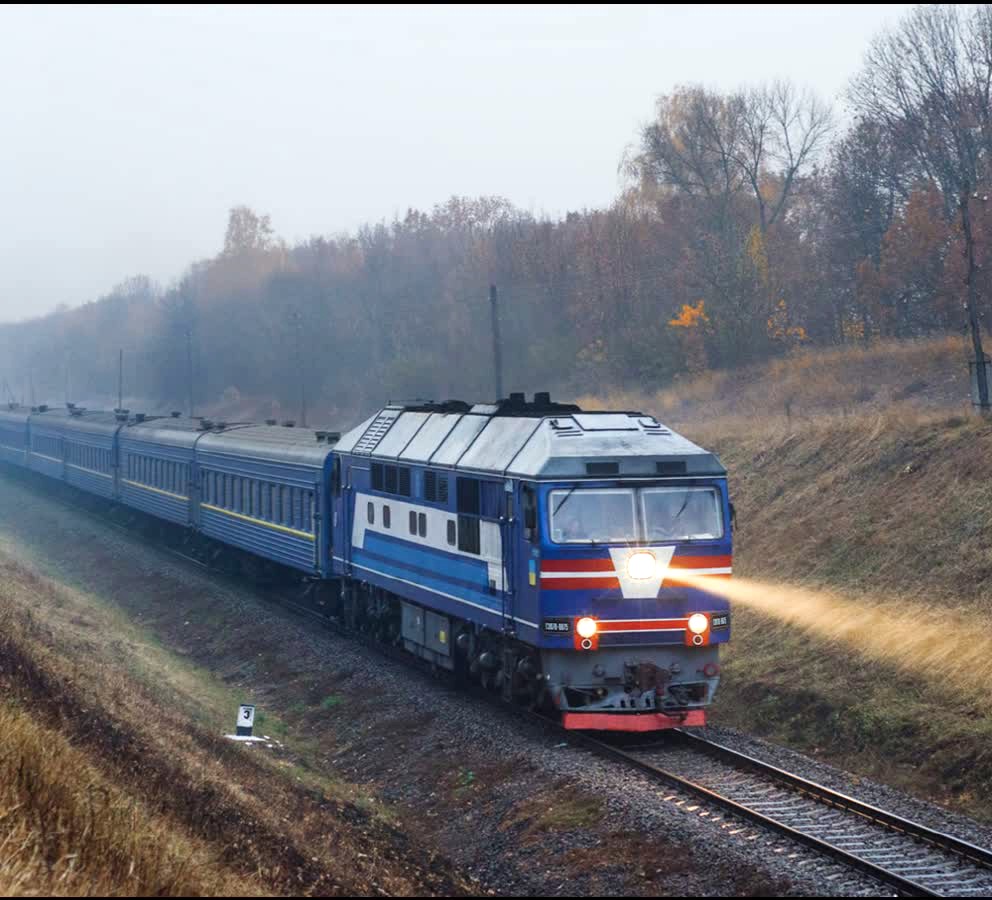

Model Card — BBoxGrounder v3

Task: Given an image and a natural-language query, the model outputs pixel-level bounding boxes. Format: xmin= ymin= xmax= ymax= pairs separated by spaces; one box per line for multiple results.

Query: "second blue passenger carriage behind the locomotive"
xmin=119 ymin=419 xmax=202 ymax=525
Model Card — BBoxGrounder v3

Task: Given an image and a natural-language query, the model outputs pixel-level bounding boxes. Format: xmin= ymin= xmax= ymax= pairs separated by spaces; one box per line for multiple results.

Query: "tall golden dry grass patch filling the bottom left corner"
xmin=0 ymin=705 xmax=260 ymax=897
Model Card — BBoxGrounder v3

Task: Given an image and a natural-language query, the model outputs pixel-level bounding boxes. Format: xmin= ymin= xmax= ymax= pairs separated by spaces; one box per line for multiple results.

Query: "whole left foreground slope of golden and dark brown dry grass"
xmin=0 ymin=553 xmax=463 ymax=896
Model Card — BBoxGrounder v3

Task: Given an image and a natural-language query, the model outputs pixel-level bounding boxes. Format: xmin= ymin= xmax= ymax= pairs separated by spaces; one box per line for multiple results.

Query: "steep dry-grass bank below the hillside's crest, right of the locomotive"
xmin=712 ymin=415 xmax=992 ymax=815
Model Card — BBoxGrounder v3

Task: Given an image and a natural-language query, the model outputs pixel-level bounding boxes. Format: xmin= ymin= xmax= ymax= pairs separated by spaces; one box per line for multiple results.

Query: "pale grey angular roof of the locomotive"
xmin=336 ymin=401 xmax=726 ymax=480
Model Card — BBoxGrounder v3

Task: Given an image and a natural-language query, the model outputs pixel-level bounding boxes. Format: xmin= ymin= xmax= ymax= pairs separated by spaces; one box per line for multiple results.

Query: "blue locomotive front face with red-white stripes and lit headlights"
xmin=532 ymin=477 xmax=731 ymax=730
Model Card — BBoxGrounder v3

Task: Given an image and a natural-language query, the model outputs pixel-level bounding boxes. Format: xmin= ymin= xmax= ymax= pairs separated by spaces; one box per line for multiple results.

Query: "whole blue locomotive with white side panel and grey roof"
xmin=332 ymin=394 xmax=731 ymax=731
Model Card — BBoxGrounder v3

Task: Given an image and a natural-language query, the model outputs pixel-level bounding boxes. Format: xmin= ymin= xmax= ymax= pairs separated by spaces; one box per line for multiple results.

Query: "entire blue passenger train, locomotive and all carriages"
xmin=0 ymin=393 xmax=733 ymax=732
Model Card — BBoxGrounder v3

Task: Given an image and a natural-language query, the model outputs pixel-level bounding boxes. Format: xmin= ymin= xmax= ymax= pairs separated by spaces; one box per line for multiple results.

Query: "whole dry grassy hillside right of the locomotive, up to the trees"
xmin=584 ymin=339 xmax=992 ymax=817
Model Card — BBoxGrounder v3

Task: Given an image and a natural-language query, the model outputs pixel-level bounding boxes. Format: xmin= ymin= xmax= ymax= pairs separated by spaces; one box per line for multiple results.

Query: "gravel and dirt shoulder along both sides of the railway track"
xmin=0 ymin=473 xmax=992 ymax=896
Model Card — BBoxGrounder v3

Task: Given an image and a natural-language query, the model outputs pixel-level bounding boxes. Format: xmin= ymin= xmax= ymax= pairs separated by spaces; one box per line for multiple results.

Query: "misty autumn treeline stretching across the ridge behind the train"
xmin=0 ymin=4 xmax=992 ymax=418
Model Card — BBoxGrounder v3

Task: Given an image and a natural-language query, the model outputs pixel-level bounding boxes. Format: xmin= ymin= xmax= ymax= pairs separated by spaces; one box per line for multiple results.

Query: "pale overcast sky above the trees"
xmin=0 ymin=4 xmax=908 ymax=321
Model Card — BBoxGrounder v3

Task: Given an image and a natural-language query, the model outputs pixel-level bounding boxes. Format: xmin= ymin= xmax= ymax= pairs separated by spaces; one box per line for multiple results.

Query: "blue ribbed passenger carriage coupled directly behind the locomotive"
xmin=196 ymin=426 xmax=332 ymax=574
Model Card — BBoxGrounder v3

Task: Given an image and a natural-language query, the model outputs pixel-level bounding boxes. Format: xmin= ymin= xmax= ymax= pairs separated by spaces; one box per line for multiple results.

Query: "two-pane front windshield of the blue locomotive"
xmin=549 ymin=487 xmax=723 ymax=544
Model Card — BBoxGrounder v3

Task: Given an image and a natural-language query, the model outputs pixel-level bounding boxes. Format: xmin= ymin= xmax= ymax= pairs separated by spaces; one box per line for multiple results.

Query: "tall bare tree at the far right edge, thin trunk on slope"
xmin=849 ymin=4 xmax=992 ymax=411
